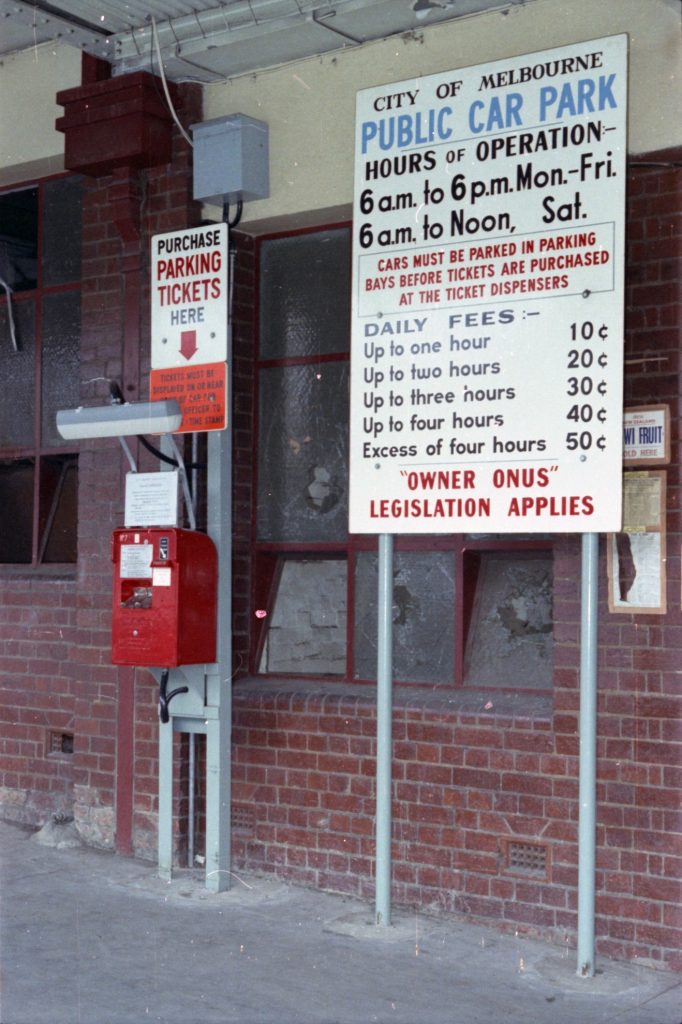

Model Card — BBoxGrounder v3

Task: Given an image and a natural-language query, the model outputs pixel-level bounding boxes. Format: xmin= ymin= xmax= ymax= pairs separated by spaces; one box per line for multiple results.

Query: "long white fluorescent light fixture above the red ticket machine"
xmin=56 ymin=398 xmax=182 ymax=440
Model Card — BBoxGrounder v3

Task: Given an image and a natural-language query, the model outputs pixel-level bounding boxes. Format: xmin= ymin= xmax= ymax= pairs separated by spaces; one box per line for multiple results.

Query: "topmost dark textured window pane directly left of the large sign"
xmin=260 ymin=228 xmax=350 ymax=359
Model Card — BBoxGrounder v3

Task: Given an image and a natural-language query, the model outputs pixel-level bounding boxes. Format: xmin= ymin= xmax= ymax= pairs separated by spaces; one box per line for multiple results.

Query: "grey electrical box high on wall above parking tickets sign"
xmin=191 ymin=114 xmax=270 ymax=206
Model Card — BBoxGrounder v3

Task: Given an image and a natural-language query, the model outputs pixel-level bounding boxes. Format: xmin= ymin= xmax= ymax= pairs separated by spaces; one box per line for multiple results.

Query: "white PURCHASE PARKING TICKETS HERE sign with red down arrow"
xmin=152 ymin=224 xmax=227 ymax=370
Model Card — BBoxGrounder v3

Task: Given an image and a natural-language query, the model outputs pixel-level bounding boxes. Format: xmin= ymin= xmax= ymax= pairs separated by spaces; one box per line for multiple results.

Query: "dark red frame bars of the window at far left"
xmin=0 ymin=172 xmax=82 ymax=575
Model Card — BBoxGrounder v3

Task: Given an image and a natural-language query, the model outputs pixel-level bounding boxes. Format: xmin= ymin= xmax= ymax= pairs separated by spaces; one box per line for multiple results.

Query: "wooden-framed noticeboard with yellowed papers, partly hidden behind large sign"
xmin=607 ymin=469 xmax=667 ymax=615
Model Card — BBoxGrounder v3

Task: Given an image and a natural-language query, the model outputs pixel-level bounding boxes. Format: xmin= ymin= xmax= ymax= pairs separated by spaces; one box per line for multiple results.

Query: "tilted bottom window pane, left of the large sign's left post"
xmin=259 ymin=559 xmax=347 ymax=676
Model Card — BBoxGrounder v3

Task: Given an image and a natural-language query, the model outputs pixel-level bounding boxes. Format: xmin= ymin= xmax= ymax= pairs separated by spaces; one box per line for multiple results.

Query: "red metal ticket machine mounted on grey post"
xmin=112 ymin=526 xmax=218 ymax=669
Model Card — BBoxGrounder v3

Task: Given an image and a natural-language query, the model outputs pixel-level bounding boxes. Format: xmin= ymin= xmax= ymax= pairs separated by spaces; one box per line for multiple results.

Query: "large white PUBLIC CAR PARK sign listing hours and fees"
xmin=350 ymin=36 xmax=628 ymax=534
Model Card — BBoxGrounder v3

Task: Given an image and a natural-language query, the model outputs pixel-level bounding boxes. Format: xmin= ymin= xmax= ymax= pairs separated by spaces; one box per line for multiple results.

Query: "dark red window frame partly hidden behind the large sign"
xmin=249 ymin=221 xmax=554 ymax=695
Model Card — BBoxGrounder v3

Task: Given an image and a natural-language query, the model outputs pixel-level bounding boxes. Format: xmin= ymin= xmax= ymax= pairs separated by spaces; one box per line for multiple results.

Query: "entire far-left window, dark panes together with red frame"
xmin=0 ymin=177 xmax=82 ymax=566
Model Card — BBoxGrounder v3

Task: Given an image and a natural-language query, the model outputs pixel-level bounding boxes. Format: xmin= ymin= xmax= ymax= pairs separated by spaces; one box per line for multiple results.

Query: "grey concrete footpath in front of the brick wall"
xmin=0 ymin=823 xmax=682 ymax=1024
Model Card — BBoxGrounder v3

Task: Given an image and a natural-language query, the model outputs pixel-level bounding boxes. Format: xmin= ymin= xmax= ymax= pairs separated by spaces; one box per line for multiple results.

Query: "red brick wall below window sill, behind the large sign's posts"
xmin=232 ymin=663 xmax=682 ymax=970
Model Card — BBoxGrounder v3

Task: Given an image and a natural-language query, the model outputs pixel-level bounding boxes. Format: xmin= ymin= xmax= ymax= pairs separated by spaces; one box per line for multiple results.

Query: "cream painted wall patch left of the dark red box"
xmin=0 ymin=43 xmax=81 ymax=185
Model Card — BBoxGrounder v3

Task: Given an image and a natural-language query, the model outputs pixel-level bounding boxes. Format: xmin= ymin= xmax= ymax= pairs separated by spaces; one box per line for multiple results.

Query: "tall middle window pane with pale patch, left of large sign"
xmin=257 ymin=362 xmax=348 ymax=542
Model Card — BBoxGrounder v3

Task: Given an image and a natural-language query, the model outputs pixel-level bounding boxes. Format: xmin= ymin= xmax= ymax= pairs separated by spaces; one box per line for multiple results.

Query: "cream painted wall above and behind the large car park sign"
xmin=204 ymin=0 xmax=682 ymax=230
